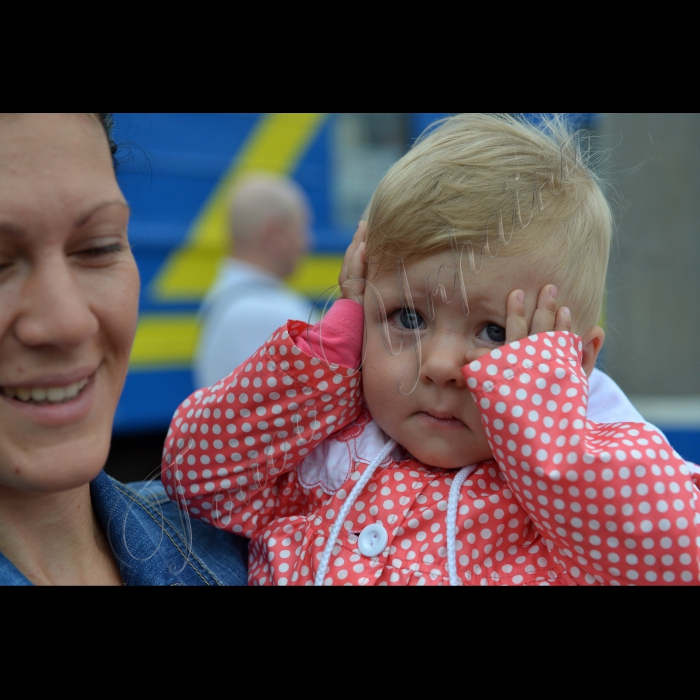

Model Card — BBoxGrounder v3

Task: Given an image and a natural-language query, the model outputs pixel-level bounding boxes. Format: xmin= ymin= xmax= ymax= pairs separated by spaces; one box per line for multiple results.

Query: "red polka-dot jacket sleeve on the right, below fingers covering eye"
xmin=462 ymin=332 xmax=700 ymax=584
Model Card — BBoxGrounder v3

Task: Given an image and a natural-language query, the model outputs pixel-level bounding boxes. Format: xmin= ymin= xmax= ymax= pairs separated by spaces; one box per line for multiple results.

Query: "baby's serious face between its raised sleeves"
xmin=362 ymin=250 xmax=551 ymax=469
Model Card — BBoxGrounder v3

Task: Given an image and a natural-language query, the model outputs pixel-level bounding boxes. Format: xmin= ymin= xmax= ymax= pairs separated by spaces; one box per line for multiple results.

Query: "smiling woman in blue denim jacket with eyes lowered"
xmin=0 ymin=114 xmax=246 ymax=585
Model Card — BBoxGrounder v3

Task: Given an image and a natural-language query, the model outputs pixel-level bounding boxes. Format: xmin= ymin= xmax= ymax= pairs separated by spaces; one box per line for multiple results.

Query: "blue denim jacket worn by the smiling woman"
xmin=0 ymin=472 xmax=248 ymax=586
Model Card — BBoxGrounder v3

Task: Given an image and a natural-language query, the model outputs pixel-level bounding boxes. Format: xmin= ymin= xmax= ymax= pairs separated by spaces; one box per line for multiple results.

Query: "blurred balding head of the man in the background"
xmin=229 ymin=174 xmax=311 ymax=278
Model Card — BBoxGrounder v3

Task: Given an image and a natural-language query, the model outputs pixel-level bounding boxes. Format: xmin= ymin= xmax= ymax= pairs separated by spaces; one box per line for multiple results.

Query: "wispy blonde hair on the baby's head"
xmin=364 ymin=114 xmax=612 ymax=335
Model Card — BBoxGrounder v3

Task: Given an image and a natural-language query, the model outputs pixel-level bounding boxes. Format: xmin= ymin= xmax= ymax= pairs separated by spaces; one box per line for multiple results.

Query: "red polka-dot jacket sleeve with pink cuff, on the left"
xmin=162 ymin=321 xmax=360 ymax=537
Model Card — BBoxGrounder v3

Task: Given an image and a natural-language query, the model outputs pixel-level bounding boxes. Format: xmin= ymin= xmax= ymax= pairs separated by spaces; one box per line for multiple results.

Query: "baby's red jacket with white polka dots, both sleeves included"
xmin=163 ymin=322 xmax=698 ymax=585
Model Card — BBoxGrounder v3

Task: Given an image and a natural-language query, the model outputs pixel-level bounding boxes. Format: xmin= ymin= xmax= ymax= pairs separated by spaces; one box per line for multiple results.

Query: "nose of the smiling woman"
xmin=15 ymin=258 xmax=99 ymax=347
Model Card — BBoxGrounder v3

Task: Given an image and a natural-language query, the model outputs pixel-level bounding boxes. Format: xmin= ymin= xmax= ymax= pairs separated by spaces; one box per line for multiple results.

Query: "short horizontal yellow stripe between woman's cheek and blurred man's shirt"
xmin=129 ymin=313 xmax=199 ymax=369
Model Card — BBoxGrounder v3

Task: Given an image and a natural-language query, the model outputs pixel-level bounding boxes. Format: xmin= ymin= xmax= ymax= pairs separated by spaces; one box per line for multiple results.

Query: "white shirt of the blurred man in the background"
xmin=194 ymin=258 xmax=312 ymax=387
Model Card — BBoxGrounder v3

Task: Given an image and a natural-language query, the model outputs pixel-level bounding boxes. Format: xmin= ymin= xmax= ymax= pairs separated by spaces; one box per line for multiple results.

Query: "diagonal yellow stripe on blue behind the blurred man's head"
xmin=151 ymin=113 xmax=326 ymax=301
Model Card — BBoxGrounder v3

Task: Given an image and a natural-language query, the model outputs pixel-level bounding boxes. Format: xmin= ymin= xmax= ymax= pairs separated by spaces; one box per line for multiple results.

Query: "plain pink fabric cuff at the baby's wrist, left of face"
xmin=295 ymin=299 xmax=365 ymax=367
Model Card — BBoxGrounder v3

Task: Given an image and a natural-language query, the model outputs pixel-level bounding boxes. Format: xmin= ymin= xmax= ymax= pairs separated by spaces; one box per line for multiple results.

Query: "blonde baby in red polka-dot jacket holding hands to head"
xmin=162 ymin=115 xmax=700 ymax=585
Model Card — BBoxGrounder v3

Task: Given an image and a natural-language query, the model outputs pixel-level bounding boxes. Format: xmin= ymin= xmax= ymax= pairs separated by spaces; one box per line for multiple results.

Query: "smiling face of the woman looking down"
xmin=0 ymin=114 xmax=139 ymax=497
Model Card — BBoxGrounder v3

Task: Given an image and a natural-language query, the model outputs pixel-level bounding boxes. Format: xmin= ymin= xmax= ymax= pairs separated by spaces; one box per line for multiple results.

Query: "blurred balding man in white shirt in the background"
xmin=194 ymin=175 xmax=311 ymax=387
